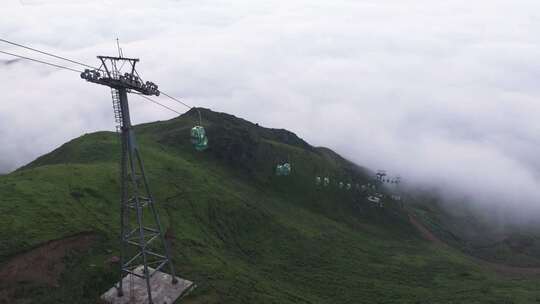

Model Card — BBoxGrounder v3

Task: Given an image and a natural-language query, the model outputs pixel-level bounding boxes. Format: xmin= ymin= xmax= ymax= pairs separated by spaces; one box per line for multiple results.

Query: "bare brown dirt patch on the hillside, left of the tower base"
xmin=0 ymin=233 xmax=97 ymax=286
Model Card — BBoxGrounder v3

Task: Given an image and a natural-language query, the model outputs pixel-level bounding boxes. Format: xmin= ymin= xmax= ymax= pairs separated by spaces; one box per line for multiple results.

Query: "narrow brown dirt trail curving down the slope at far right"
xmin=409 ymin=214 xmax=540 ymax=277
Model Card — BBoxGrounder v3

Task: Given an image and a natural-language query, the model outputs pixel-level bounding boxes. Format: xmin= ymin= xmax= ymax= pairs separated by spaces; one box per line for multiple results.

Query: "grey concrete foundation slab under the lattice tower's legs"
xmin=101 ymin=265 xmax=195 ymax=304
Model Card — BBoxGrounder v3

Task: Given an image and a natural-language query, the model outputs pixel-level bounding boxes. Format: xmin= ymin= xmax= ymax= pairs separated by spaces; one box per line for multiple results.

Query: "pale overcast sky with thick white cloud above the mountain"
xmin=0 ymin=0 xmax=540 ymax=223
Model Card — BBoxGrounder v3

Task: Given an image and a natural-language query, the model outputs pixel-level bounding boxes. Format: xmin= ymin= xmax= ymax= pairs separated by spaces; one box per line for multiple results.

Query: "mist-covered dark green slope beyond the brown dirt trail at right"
xmin=412 ymin=192 xmax=540 ymax=267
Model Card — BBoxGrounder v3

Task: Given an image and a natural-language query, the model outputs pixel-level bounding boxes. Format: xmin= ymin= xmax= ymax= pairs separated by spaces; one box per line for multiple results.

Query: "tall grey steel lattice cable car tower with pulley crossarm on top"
xmin=81 ymin=54 xmax=177 ymax=303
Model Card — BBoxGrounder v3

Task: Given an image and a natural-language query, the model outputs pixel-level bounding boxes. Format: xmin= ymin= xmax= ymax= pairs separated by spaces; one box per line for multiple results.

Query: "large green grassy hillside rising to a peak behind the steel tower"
xmin=0 ymin=109 xmax=540 ymax=304
